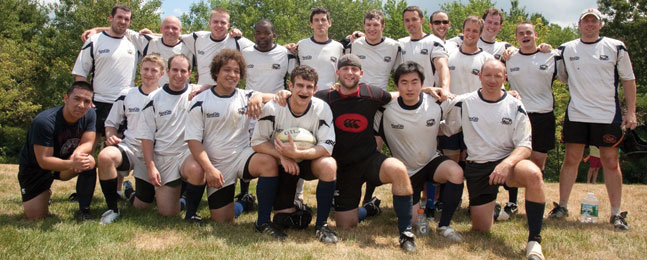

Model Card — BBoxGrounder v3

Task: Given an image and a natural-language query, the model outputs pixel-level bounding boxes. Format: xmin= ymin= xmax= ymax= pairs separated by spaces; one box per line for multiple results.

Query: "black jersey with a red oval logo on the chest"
xmin=315 ymin=83 xmax=391 ymax=164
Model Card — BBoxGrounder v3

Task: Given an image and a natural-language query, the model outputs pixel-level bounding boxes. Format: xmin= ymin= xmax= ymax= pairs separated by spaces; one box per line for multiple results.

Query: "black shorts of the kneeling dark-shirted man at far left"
xmin=18 ymin=164 xmax=54 ymax=202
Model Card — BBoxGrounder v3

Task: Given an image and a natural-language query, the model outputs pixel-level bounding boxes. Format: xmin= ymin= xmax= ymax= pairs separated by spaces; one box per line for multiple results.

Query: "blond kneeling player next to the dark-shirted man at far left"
xmin=97 ymin=54 xmax=166 ymax=224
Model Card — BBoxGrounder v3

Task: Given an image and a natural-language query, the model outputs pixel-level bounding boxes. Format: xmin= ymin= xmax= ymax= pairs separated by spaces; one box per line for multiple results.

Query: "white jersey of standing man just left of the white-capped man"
xmin=505 ymin=50 xmax=557 ymax=113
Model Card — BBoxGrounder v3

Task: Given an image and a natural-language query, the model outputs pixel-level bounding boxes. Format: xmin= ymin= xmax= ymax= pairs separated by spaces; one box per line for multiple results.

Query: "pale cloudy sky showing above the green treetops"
xmin=162 ymin=0 xmax=597 ymax=26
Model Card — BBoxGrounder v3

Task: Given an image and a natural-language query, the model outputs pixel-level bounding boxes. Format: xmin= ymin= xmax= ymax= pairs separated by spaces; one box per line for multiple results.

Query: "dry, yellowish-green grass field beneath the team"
xmin=0 ymin=165 xmax=647 ymax=259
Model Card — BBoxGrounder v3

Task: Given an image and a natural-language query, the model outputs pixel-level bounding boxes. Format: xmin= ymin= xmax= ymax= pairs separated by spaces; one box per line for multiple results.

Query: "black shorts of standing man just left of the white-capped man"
xmin=528 ymin=111 xmax=555 ymax=153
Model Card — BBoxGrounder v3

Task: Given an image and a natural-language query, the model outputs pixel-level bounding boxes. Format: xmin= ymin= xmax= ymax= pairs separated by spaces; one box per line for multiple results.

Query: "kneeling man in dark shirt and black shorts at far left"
xmin=18 ymin=81 xmax=96 ymax=220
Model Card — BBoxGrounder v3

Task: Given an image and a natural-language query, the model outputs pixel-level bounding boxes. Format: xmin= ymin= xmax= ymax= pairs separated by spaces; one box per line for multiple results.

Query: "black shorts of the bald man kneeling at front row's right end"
xmin=465 ymin=159 xmax=506 ymax=206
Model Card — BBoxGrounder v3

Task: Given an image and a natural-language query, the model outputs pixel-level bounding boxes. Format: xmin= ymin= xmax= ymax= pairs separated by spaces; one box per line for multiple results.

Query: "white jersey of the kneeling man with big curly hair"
xmin=184 ymin=88 xmax=256 ymax=165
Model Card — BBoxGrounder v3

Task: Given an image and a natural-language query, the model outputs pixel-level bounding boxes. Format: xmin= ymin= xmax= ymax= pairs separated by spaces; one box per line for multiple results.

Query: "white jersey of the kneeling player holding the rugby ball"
xmin=252 ymin=97 xmax=335 ymax=155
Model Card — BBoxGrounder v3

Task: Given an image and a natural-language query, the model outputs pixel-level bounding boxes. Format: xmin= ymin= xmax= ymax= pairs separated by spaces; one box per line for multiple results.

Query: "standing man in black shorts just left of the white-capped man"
xmin=506 ymin=21 xmax=557 ymax=174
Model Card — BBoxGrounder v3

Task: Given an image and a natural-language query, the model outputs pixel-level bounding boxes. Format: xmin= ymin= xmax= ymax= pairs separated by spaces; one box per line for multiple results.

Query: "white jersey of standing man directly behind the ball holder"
xmin=297 ymin=37 xmax=344 ymax=89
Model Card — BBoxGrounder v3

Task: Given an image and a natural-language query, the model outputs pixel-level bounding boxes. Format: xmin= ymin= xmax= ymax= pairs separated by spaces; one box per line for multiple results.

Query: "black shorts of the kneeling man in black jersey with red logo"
xmin=335 ymin=151 xmax=388 ymax=211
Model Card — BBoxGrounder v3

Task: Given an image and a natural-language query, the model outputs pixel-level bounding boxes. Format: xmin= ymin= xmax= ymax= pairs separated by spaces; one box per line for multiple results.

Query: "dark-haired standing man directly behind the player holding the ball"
xmin=288 ymin=7 xmax=344 ymax=89
